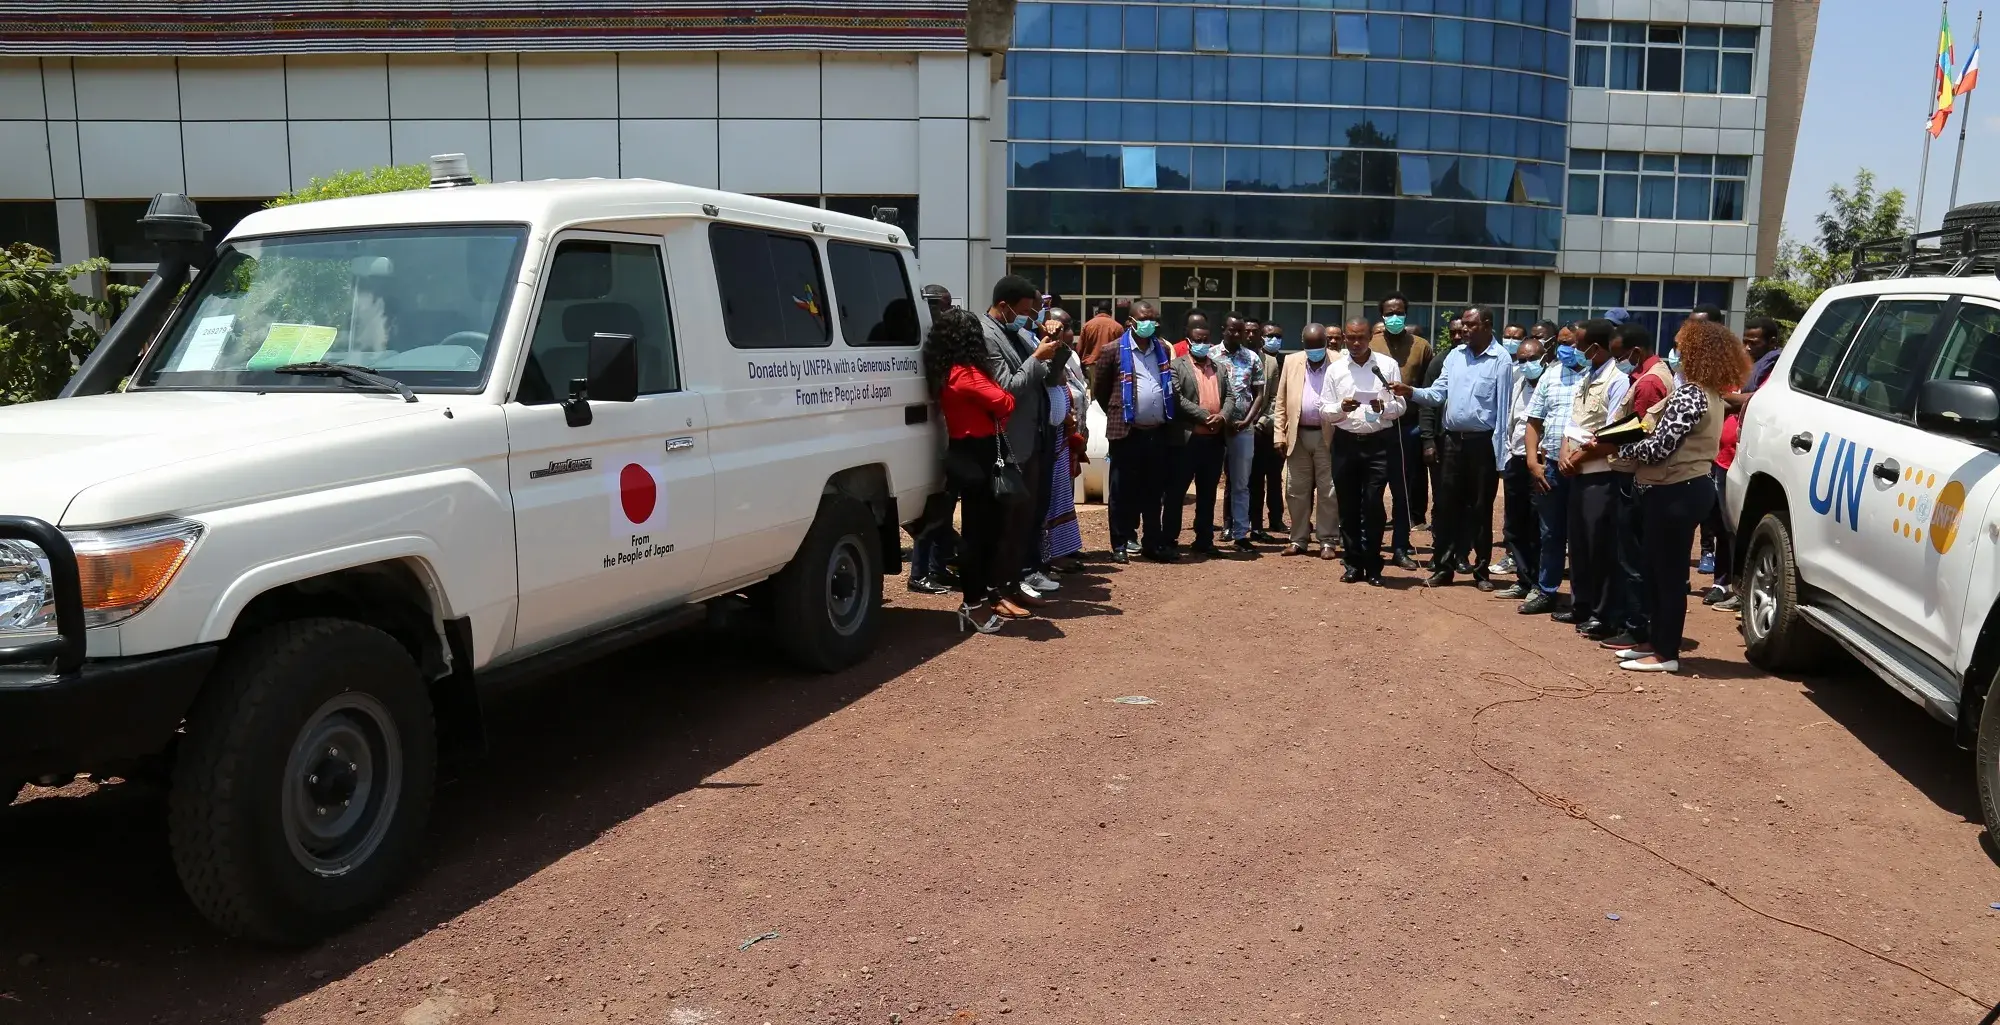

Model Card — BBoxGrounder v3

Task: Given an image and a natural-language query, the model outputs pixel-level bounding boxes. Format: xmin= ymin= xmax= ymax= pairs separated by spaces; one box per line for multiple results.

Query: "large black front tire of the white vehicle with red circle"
xmin=168 ymin=619 xmax=438 ymax=945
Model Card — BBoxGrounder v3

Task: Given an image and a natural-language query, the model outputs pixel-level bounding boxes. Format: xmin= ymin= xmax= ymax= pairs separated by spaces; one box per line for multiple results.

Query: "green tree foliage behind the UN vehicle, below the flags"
xmin=1750 ymin=168 xmax=1916 ymax=328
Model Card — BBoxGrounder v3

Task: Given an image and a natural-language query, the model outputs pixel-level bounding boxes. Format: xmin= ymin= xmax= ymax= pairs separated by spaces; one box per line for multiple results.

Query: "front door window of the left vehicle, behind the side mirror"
xmin=520 ymin=238 xmax=680 ymax=406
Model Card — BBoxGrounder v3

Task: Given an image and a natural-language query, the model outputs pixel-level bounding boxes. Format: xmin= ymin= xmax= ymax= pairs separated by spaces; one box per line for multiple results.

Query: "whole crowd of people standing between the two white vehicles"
xmin=910 ymin=276 xmax=1782 ymax=673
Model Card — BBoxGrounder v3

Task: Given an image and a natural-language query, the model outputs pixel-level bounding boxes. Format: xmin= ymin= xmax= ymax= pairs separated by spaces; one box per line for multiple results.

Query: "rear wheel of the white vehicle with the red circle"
xmin=770 ymin=494 xmax=882 ymax=673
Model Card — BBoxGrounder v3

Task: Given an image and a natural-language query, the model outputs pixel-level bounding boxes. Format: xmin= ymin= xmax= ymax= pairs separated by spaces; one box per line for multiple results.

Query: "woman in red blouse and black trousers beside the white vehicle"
xmin=924 ymin=308 xmax=1030 ymax=633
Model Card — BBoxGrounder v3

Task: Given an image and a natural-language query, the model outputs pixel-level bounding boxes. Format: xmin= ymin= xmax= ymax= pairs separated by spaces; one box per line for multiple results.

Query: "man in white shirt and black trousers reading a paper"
xmin=1320 ymin=318 xmax=1404 ymax=587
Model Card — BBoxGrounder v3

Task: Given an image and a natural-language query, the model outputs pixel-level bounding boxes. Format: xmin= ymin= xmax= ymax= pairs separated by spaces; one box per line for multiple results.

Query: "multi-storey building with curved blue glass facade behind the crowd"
xmin=1006 ymin=0 xmax=1810 ymax=340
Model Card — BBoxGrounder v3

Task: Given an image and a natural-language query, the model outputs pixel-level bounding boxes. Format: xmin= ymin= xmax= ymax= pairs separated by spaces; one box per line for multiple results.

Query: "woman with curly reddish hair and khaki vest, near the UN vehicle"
xmin=1568 ymin=320 xmax=1750 ymax=673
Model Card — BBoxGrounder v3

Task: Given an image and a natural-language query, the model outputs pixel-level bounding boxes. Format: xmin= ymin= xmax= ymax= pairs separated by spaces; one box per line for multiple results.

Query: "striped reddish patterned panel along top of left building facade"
xmin=0 ymin=0 xmax=966 ymax=56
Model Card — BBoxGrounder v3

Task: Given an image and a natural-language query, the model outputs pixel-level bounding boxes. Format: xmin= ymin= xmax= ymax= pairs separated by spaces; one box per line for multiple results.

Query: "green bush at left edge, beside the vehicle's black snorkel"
xmin=0 ymin=242 xmax=138 ymax=406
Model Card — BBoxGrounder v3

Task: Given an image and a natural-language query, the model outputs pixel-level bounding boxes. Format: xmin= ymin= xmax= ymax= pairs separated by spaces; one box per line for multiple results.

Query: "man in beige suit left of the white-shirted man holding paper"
xmin=1270 ymin=324 xmax=1340 ymax=559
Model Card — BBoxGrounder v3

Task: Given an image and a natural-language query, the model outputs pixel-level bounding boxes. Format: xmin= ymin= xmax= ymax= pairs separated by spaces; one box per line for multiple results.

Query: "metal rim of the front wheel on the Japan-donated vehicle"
xmin=282 ymin=691 xmax=402 ymax=877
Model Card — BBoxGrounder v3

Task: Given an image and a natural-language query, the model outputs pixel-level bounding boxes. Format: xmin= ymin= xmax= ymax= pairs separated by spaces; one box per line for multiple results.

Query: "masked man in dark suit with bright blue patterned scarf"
xmin=1090 ymin=298 xmax=1180 ymax=563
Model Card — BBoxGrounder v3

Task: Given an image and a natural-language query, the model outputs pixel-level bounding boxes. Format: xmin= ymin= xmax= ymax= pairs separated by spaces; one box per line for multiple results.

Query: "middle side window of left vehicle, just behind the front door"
xmin=708 ymin=224 xmax=832 ymax=348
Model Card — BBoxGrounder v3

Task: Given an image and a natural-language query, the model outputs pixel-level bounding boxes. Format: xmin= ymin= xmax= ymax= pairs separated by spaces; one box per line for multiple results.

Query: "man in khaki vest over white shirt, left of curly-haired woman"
xmin=1558 ymin=320 xmax=1632 ymax=641
